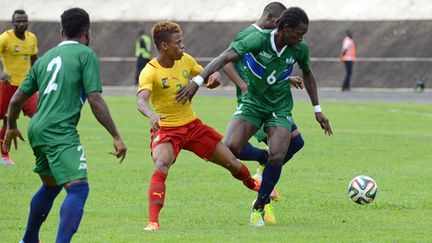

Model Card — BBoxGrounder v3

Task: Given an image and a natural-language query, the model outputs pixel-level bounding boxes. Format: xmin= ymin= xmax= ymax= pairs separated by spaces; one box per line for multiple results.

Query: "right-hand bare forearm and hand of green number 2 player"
xmin=87 ymin=92 xmax=127 ymax=163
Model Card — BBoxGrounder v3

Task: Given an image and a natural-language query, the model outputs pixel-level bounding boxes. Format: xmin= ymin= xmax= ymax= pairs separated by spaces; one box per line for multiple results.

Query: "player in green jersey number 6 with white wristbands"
xmin=176 ymin=7 xmax=333 ymax=226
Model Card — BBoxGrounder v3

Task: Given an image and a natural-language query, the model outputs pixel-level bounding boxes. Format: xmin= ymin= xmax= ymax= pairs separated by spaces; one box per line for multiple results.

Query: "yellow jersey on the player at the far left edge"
xmin=0 ymin=29 xmax=38 ymax=86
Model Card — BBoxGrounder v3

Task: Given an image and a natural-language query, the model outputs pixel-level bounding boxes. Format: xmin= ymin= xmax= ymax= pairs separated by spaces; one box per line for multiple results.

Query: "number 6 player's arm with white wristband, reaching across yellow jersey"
xmin=176 ymin=48 xmax=240 ymax=104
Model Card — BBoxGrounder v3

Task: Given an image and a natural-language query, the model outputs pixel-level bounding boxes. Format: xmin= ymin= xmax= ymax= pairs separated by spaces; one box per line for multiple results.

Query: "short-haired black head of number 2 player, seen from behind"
xmin=61 ymin=8 xmax=90 ymax=38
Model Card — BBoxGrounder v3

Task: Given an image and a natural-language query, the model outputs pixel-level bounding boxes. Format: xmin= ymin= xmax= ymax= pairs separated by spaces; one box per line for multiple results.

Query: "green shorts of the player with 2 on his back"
xmin=33 ymin=143 xmax=87 ymax=185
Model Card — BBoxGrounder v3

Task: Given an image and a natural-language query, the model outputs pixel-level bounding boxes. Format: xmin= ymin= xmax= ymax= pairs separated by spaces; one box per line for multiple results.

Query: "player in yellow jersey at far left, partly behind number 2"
xmin=0 ymin=10 xmax=38 ymax=164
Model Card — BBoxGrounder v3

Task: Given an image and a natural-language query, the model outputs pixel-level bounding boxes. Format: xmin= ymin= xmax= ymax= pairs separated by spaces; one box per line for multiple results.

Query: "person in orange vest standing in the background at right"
xmin=341 ymin=30 xmax=357 ymax=91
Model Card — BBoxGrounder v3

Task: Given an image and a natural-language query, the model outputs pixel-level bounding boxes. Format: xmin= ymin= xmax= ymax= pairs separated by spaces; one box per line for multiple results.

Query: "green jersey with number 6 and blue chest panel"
xmin=231 ymin=30 xmax=310 ymax=113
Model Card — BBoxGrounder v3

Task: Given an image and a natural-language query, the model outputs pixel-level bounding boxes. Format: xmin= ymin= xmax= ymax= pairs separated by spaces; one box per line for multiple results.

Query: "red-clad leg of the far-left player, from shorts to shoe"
xmin=0 ymin=82 xmax=18 ymax=164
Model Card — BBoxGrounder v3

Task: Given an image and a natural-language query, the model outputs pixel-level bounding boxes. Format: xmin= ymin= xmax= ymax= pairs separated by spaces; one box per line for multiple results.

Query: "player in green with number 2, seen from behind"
xmin=3 ymin=8 xmax=126 ymax=243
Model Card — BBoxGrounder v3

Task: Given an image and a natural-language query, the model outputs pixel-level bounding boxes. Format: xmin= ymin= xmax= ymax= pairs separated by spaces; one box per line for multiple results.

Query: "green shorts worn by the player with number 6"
xmin=232 ymin=103 xmax=294 ymax=136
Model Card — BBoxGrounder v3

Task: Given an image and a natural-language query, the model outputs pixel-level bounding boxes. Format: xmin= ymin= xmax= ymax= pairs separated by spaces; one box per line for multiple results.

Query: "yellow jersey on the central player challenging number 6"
xmin=138 ymin=53 xmax=203 ymax=127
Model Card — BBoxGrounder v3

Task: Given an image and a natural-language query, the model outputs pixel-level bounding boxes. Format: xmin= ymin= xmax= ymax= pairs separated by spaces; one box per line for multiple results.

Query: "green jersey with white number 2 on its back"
xmin=19 ymin=41 xmax=102 ymax=147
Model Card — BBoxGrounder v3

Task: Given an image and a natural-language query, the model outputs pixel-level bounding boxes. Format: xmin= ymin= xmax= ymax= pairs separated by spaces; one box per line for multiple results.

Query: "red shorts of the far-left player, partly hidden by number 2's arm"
xmin=0 ymin=83 xmax=38 ymax=119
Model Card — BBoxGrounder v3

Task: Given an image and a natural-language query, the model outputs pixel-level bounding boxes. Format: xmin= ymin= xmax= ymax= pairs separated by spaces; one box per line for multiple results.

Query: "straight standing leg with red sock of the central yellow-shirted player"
xmin=144 ymin=139 xmax=176 ymax=231
